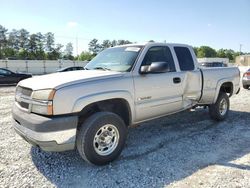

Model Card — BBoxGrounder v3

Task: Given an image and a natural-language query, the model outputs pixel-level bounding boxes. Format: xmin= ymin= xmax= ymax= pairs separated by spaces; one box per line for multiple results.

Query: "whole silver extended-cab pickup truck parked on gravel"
xmin=12 ymin=43 xmax=240 ymax=165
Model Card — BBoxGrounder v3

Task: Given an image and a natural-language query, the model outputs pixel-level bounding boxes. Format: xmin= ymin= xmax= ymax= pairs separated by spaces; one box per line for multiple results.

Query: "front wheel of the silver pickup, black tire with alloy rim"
xmin=76 ymin=112 xmax=127 ymax=165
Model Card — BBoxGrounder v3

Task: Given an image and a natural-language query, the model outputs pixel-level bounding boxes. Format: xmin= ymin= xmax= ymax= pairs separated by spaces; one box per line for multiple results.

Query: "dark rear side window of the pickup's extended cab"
xmin=174 ymin=47 xmax=194 ymax=71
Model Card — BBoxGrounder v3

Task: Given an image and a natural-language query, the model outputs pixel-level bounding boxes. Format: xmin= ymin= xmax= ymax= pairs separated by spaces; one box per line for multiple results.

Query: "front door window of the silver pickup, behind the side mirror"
xmin=142 ymin=46 xmax=176 ymax=72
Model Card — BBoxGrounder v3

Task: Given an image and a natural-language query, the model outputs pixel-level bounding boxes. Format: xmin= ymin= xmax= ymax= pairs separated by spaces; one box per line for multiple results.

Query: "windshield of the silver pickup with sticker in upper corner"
xmin=85 ymin=46 xmax=142 ymax=72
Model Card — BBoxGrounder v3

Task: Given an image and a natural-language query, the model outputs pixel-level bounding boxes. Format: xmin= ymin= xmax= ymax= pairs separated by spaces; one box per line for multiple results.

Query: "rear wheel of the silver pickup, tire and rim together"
xmin=209 ymin=93 xmax=230 ymax=121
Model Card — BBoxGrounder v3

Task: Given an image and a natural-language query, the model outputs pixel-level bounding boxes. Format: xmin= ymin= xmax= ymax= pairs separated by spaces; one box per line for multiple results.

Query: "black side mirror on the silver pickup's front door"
xmin=140 ymin=62 xmax=170 ymax=74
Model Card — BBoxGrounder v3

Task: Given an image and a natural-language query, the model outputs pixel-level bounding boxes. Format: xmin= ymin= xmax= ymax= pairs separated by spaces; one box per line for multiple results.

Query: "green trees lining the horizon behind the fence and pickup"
xmin=0 ymin=25 xmax=248 ymax=61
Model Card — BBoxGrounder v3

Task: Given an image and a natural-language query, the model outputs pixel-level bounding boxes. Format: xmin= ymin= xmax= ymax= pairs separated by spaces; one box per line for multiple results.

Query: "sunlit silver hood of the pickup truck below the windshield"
xmin=18 ymin=70 xmax=124 ymax=90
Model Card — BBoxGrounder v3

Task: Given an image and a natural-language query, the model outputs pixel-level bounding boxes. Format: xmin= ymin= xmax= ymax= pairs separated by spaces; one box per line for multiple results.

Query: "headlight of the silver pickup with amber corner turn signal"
xmin=31 ymin=89 xmax=55 ymax=115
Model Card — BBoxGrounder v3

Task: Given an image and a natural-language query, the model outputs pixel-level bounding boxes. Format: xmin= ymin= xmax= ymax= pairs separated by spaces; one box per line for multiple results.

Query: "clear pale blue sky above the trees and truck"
xmin=0 ymin=0 xmax=250 ymax=55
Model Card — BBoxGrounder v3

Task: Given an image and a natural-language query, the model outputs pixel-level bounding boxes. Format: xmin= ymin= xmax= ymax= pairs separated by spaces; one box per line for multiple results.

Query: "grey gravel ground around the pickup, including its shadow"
xmin=0 ymin=87 xmax=250 ymax=187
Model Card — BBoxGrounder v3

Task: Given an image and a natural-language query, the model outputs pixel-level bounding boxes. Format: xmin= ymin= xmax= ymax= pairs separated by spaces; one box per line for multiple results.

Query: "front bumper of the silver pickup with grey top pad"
xmin=12 ymin=104 xmax=78 ymax=151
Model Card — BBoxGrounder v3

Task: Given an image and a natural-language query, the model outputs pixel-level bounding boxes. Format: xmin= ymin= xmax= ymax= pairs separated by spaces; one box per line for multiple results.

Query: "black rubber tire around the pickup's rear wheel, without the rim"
xmin=209 ymin=92 xmax=230 ymax=121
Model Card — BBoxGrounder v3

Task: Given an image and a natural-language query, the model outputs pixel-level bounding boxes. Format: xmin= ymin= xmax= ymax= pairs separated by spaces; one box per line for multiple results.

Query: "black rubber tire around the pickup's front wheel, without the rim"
xmin=76 ymin=112 xmax=127 ymax=165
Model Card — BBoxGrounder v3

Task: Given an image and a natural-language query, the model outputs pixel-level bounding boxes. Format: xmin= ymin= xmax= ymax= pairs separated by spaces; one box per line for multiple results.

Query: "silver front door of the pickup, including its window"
xmin=134 ymin=46 xmax=183 ymax=122
